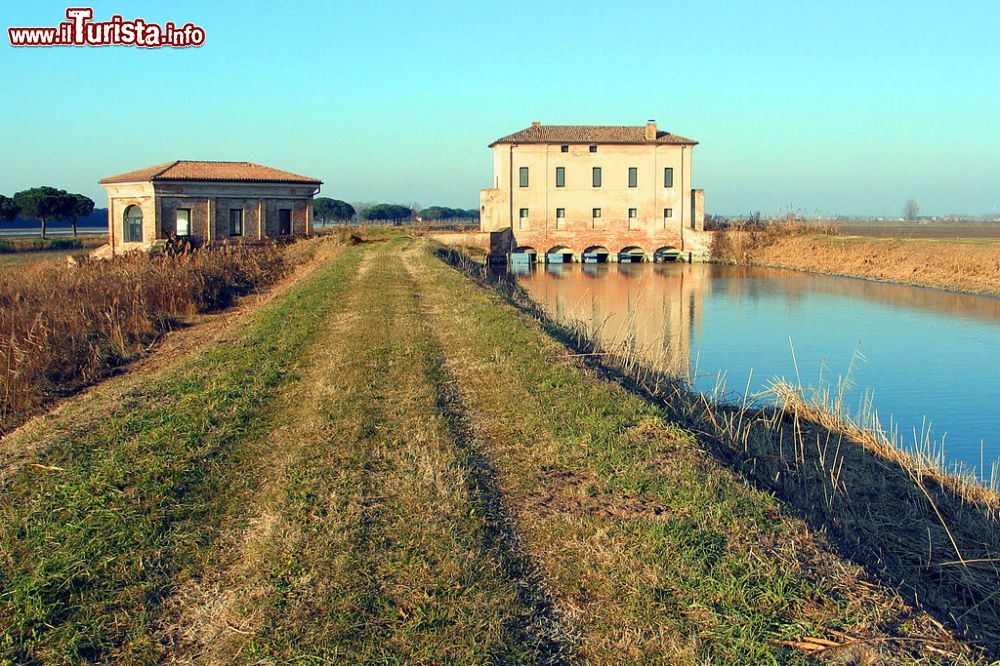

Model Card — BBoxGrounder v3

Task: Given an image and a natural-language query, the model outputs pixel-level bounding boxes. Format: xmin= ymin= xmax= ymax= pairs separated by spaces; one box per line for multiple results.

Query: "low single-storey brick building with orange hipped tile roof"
xmin=100 ymin=160 xmax=323 ymax=253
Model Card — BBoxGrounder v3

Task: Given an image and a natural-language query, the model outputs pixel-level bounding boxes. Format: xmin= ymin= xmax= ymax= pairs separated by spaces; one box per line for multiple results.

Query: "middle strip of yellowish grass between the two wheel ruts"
xmin=239 ymin=237 xmax=532 ymax=663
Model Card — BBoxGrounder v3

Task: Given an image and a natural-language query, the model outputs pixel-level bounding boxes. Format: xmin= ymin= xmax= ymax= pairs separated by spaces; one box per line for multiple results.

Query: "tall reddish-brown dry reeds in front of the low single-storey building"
xmin=0 ymin=245 xmax=286 ymax=434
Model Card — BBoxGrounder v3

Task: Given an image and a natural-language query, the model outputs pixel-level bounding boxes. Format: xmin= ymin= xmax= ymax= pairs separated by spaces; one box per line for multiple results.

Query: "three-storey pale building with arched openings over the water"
xmin=480 ymin=120 xmax=705 ymax=261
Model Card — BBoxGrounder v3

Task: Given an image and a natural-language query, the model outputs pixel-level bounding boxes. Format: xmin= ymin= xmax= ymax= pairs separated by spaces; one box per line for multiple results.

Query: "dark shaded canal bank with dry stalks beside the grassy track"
xmin=443 ymin=241 xmax=1000 ymax=652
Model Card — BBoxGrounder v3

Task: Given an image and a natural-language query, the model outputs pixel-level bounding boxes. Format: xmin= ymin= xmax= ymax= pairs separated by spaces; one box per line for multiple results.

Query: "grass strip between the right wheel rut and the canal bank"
xmin=412 ymin=244 xmax=944 ymax=664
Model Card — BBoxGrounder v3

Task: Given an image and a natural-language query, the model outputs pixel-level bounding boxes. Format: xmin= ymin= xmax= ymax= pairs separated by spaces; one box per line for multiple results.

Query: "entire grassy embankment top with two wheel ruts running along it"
xmin=0 ymin=236 xmax=996 ymax=663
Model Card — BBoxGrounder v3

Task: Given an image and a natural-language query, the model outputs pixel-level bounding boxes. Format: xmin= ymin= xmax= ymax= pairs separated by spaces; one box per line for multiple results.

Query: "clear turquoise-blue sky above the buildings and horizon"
xmin=0 ymin=0 xmax=1000 ymax=215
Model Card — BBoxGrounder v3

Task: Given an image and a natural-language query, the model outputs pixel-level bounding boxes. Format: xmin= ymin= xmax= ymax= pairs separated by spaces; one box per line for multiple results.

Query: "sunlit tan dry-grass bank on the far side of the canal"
xmin=712 ymin=222 xmax=1000 ymax=295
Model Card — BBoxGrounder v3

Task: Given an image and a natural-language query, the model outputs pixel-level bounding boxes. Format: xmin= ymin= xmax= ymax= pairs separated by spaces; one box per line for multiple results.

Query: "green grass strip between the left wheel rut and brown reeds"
xmin=0 ymin=250 xmax=358 ymax=662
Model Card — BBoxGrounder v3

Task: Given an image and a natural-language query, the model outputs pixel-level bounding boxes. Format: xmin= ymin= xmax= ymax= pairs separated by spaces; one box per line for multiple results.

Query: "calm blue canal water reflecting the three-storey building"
xmin=518 ymin=264 xmax=1000 ymax=477
